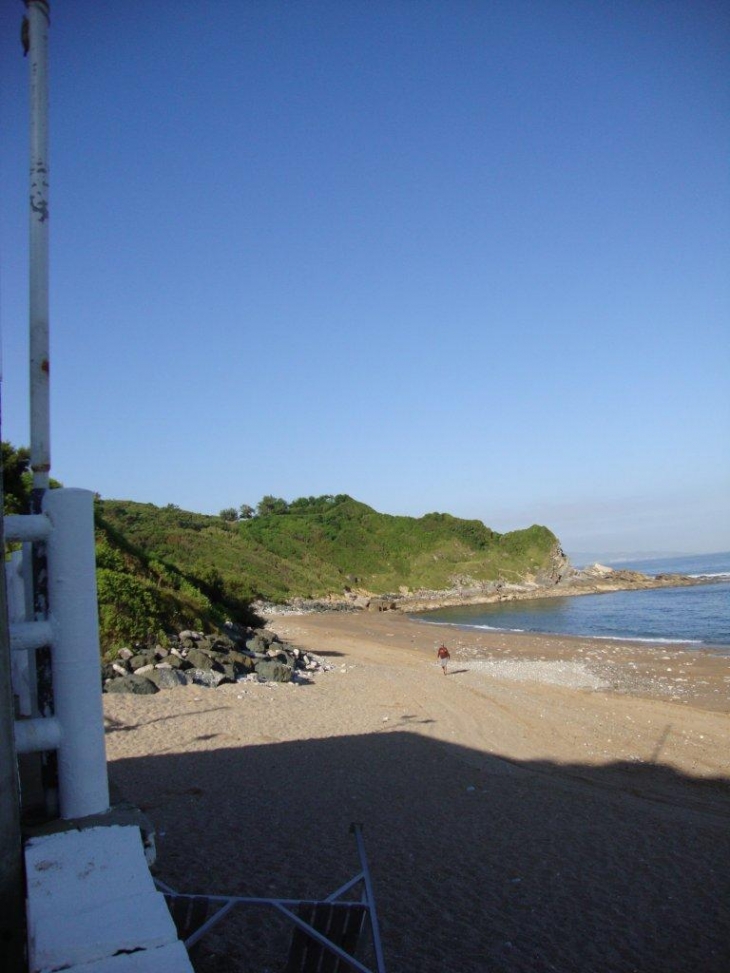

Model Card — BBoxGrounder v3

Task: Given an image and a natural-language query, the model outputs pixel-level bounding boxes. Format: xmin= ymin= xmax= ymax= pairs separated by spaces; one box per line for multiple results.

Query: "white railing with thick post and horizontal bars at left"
xmin=5 ymin=489 xmax=109 ymax=818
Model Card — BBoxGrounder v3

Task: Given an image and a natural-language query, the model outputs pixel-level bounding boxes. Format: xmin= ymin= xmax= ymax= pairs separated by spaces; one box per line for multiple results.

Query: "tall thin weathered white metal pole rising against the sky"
xmin=25 ymin=0 xmax=51 ymax=494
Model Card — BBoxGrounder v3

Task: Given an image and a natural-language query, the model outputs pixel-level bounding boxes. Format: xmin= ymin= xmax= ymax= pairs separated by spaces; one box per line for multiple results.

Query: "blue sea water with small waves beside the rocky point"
xmin=414 ymin=552 xmax=730 ymax=655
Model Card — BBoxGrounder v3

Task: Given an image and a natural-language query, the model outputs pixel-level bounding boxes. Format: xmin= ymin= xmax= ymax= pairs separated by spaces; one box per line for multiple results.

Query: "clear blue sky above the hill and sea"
xmin=0 ymin=0 xmax=730 ymax=552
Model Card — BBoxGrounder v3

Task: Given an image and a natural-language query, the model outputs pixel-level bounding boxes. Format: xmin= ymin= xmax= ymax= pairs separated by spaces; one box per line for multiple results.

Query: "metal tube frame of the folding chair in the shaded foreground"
xmin=155 ymin=823 xmax=385 ymax=973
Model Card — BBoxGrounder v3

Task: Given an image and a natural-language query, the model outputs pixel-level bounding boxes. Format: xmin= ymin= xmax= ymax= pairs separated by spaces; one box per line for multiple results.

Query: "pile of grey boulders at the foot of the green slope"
xmin=102 ymin=629 xmax=326 ymax=694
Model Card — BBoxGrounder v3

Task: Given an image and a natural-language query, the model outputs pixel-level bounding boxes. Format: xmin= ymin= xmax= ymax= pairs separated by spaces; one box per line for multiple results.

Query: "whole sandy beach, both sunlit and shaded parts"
xmin=104 ymin=613 xmax=730 ymax=973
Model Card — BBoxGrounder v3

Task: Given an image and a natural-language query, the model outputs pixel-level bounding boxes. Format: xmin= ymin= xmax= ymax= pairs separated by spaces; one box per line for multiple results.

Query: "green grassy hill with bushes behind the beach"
xmin=91 ymin=495 xmax=558 ymax=645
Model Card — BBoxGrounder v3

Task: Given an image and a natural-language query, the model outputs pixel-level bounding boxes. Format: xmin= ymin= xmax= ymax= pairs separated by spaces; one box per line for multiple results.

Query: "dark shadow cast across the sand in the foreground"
xmin=109 ymin=726 xmax=730 ymax=973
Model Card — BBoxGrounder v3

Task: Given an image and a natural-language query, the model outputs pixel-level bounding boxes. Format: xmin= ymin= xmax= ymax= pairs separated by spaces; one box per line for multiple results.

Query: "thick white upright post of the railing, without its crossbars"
xmin=43 ymin=489 xmax=109 ymax=818
